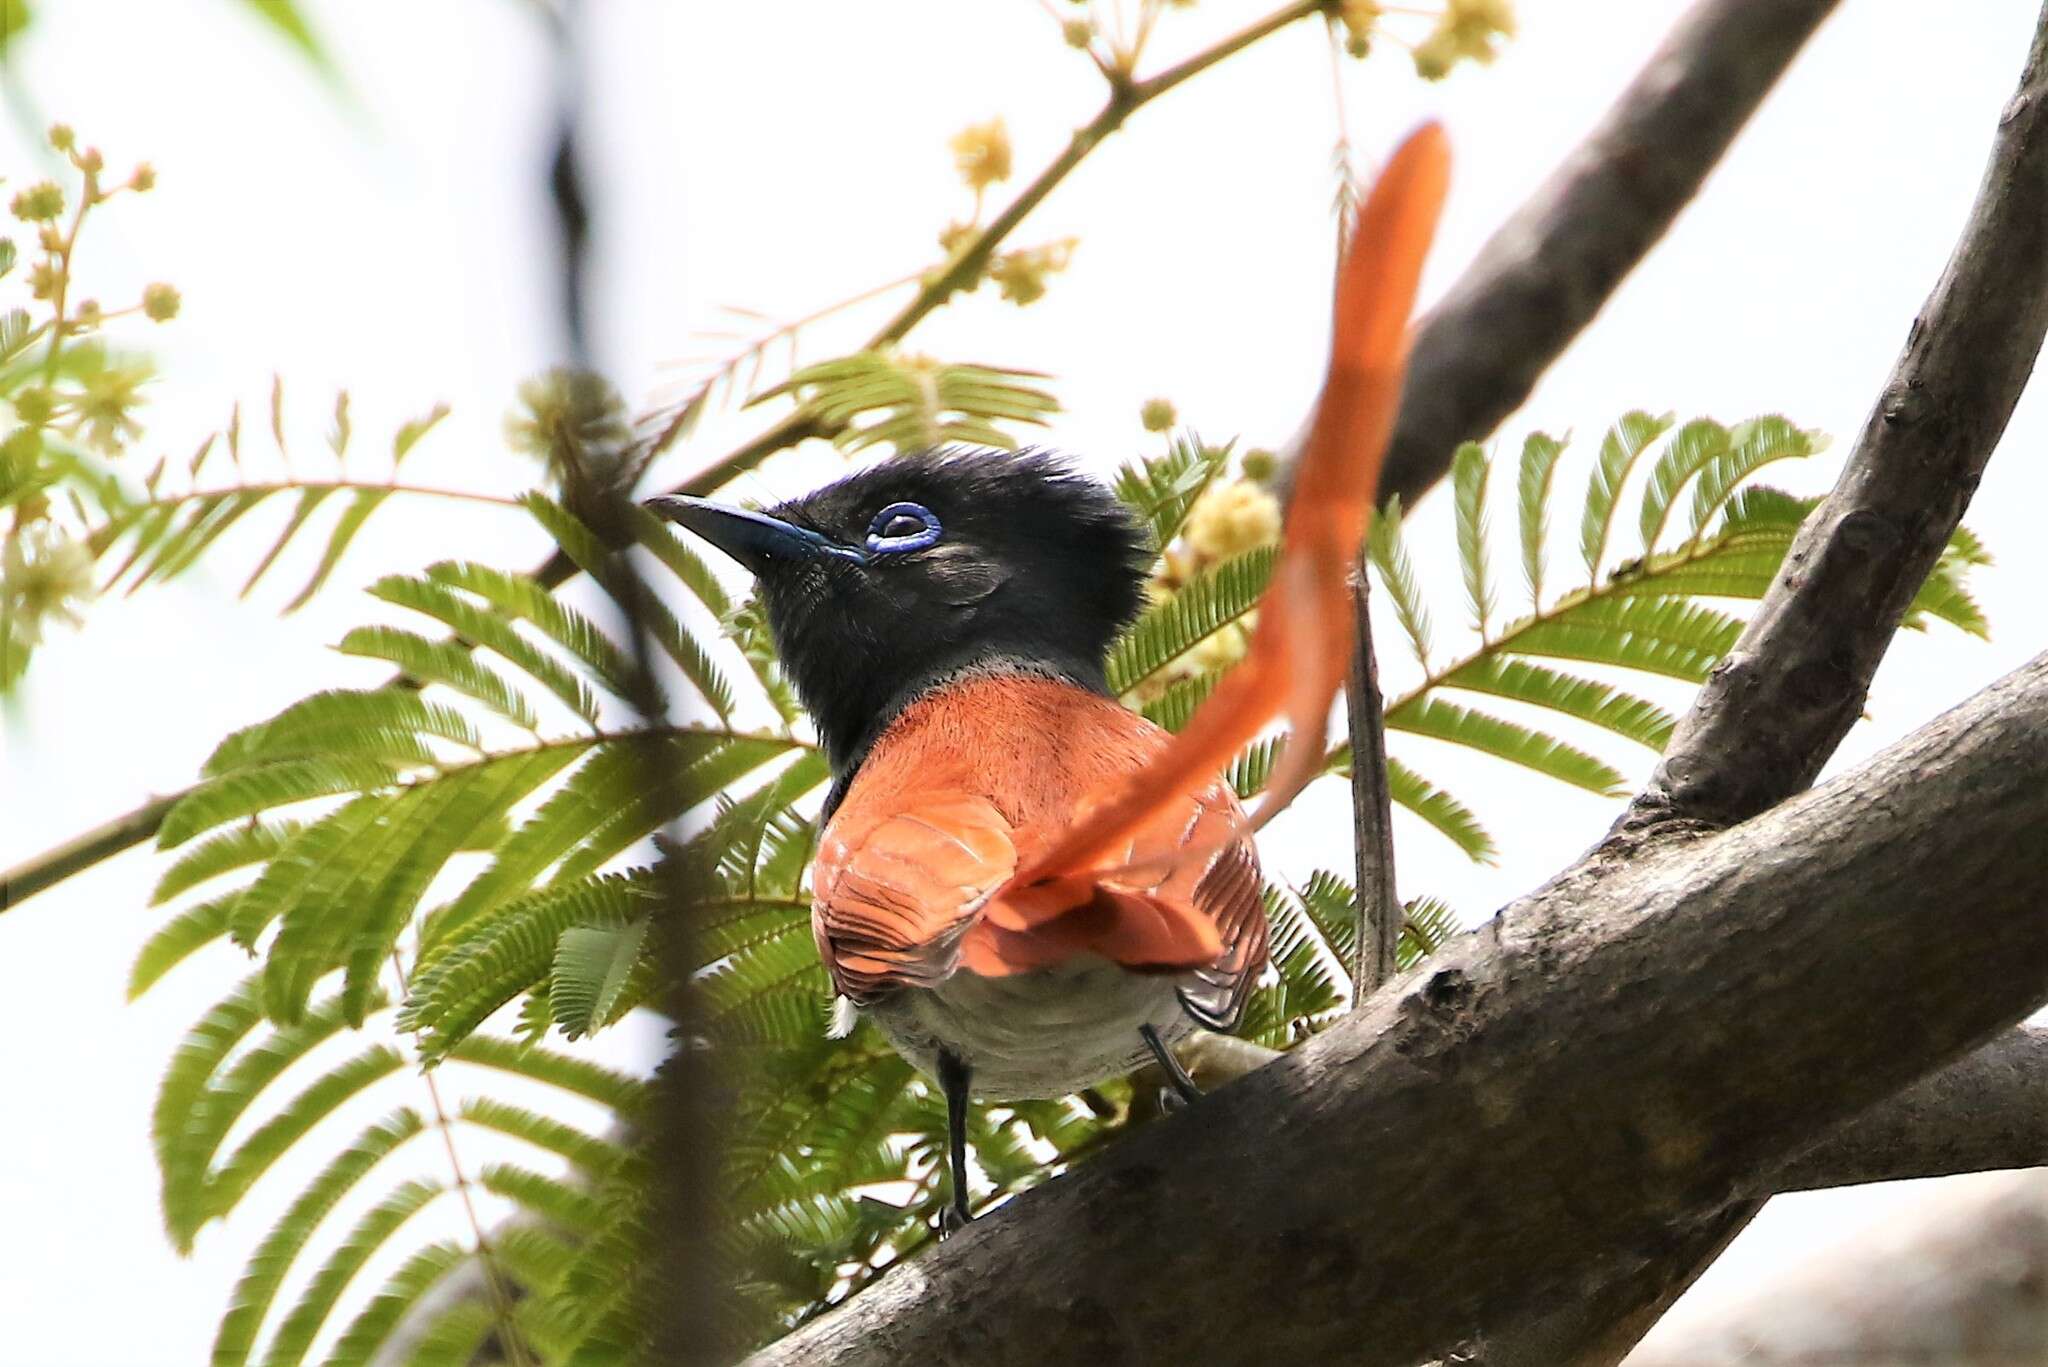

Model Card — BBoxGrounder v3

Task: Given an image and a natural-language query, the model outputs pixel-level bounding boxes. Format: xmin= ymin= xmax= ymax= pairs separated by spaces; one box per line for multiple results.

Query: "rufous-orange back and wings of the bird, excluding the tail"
xmin=811 ymin=678 xmax=1266 ymax=1023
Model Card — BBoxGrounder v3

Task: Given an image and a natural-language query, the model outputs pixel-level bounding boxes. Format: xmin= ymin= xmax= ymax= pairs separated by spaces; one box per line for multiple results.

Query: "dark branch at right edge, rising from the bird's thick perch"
xmin=1624 ymin=10 xmax=2048 ymax=826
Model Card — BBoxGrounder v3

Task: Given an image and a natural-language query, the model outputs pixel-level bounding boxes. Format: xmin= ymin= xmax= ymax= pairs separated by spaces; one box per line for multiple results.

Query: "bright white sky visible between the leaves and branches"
xmin=0 ymin=0 xmax=2048 ymax=1367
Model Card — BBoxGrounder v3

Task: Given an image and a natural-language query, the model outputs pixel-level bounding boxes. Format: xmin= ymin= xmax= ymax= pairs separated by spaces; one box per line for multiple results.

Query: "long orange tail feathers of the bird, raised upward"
xmin=1010 ymin=123 xmax=1450 ymax=887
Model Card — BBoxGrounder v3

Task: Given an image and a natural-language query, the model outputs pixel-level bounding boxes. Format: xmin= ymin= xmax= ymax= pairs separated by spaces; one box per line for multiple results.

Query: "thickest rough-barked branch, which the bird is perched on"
xmin=756 ymin=656 xmax=2048 ymax=1367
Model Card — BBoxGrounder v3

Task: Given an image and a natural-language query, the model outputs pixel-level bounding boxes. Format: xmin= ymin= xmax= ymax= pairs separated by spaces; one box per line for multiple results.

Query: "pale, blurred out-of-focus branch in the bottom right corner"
xmin=1628 ymin=1172 xmax=2048 ymax=1367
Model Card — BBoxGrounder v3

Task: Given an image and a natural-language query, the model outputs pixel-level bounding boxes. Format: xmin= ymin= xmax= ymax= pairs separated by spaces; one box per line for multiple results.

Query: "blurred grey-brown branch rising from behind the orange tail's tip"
xmin=1380 ymin=0 xmax=1837 ymax=506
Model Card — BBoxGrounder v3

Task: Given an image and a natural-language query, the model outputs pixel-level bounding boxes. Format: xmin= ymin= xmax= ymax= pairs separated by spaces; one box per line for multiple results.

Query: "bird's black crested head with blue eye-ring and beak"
xmin=647 ymin=449 xmax=1151 ymax=769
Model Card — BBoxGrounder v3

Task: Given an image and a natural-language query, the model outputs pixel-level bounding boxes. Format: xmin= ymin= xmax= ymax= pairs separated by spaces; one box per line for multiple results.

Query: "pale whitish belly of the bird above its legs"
xmin=866 ymin=955 xmax=1194 ymax=1101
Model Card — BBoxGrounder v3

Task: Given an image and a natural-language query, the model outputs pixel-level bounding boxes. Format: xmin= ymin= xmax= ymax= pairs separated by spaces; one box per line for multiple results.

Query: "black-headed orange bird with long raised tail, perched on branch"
xmin=647 ymin=125 xmax=1448 ymax=1230
